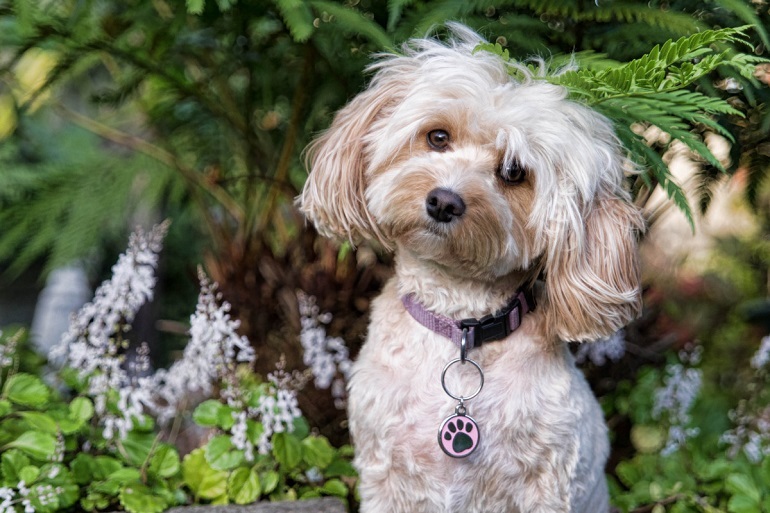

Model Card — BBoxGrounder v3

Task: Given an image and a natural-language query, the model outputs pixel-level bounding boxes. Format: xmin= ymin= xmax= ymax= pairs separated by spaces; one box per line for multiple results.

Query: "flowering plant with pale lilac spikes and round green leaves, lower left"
xmin=0 ymin=224 xmax=354 ymax=513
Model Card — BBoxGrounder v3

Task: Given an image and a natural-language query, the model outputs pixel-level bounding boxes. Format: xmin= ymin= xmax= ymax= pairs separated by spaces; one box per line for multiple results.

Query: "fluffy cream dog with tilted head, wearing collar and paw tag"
xmin=297 ymin=24 xmax=644 ymax=513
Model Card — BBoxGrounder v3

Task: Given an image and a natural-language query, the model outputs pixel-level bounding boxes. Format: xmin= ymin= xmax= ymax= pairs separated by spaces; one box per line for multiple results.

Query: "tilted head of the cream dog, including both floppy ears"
xmin=300 ymin=27 xmax=642 ymax=340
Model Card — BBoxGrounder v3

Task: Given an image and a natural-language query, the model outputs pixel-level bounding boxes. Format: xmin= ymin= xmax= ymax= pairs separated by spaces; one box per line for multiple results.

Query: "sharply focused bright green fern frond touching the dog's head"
xmin=477 ymin=26 xmax=765 ymax=226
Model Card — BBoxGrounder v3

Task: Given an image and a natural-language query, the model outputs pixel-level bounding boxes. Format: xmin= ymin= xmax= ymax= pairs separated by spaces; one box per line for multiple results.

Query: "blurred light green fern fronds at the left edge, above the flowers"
xmin=0 ymin=130 xmax=183 ymax=279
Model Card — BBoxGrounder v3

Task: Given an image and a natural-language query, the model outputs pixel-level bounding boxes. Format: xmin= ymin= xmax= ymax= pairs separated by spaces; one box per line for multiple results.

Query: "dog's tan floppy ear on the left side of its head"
xmin=297 ymin=76 xmax=399 ymax=247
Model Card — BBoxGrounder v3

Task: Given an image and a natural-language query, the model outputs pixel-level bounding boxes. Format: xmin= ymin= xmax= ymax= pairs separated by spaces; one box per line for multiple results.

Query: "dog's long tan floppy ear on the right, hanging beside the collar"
xmin=544 ymin=170 xmax=644 ymax=342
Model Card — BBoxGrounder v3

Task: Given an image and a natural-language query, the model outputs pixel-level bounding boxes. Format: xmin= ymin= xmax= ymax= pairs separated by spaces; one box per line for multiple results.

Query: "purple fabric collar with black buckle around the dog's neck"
xmin=401 ymin=290 xmax=535 ymax=349
